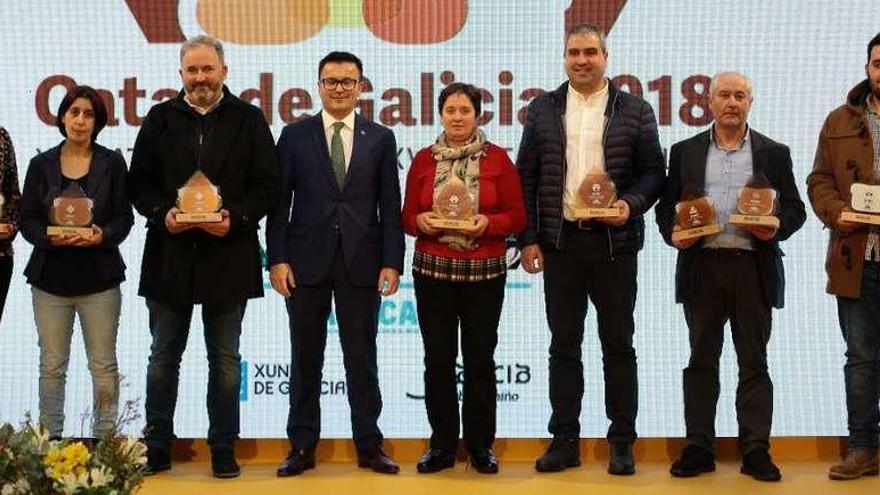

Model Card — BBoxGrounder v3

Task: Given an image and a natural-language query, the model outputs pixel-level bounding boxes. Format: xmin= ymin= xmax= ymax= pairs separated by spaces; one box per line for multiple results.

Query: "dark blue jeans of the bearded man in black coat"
xmin=144 ymin=299 xmax=247 ymax=452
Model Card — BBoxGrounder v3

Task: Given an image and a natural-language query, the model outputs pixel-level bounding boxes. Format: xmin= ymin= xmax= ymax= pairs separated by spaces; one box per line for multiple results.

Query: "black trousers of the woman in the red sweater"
xmin=413 ymin=274 xmax=506 ymax=452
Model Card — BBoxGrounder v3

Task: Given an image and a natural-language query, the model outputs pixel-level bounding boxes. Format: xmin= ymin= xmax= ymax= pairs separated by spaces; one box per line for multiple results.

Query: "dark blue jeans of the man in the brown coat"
xmin=837 ymin=262 xmax=880 ymax=451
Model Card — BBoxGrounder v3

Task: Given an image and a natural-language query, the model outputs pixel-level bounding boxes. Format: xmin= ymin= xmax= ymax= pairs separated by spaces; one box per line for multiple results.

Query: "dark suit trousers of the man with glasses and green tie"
xmin=287 ymin=247 xmax=382 ymax=451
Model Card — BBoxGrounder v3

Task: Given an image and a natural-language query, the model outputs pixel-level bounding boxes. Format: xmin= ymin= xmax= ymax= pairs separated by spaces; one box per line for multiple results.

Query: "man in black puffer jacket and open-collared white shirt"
xmin=517 ymin=24 xmax=665 ymax=474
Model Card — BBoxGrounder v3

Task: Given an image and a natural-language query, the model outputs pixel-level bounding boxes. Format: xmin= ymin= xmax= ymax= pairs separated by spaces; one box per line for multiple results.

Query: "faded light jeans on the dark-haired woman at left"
xmin=31 ymin=286 xmax=122 ymax=437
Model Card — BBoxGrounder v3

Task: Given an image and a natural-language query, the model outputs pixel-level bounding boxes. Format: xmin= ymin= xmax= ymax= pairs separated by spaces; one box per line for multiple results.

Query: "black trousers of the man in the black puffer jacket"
xmin=543 ymin=222 xmax=638 ymax=442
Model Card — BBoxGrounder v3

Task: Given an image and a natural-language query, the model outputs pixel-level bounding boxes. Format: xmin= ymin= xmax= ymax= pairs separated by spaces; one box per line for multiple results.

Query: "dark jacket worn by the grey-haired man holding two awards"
xmin=656 ymin=130 xmax=806 ymax=308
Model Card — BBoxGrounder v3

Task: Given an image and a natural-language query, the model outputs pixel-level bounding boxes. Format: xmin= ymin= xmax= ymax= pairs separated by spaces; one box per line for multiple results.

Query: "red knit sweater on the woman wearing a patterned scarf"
xmin=402 ymin=143 xmax=526 ymax=259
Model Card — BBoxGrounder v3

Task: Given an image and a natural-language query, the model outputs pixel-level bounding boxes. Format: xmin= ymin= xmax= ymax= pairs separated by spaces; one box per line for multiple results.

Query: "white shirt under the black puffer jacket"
xmin=562 ymin=80 xmax=608 ymax=220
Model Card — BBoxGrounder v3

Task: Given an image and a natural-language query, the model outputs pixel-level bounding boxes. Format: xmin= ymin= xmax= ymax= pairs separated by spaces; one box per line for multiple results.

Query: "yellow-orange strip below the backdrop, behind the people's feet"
xmin=173 ymin=437 xmax=846 ymax=462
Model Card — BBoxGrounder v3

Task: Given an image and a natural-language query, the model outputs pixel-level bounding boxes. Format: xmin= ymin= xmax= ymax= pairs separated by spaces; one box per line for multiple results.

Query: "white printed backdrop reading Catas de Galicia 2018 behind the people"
xmin=0 ymin=0 xmax=868 ymax=437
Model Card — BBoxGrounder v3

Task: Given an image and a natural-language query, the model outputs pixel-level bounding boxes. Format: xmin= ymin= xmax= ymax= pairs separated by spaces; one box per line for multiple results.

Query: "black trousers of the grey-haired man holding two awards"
xmin=684 ymin=249 xmax=773 ymax=453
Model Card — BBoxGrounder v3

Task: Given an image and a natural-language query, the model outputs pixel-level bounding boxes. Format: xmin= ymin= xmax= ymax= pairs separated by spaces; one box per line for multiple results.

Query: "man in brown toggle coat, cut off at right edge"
xmin=807 ymin=33 xmax=880 ymax=480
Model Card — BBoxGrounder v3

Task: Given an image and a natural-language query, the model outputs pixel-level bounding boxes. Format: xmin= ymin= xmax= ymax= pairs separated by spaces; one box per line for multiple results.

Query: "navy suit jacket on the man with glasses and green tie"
xmin=266 ymin=113 xmax=404 ymax=286
